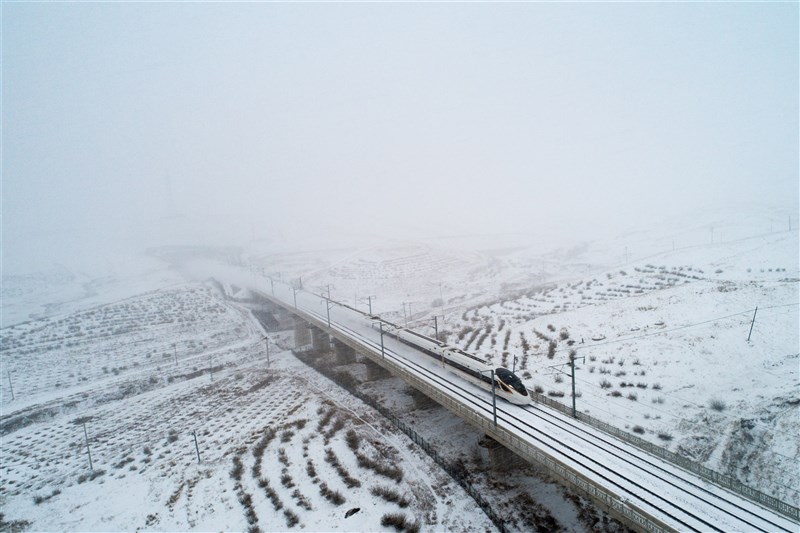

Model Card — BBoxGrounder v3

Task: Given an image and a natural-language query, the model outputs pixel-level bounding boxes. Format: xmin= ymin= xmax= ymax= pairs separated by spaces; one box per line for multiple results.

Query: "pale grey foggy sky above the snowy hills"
xmin=2 ymin=3 xmax=800 ymax=268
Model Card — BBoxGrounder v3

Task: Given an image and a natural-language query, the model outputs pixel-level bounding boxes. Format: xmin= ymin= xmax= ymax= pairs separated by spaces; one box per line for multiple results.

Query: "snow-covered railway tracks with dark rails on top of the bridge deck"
xmin=264 ymin=280 xmax=798 ymax=532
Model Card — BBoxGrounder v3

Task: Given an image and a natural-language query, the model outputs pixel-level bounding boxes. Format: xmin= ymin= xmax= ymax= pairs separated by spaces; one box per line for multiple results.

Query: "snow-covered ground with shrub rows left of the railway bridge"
xmin=0 ymin=268 xmax=620 ymax=531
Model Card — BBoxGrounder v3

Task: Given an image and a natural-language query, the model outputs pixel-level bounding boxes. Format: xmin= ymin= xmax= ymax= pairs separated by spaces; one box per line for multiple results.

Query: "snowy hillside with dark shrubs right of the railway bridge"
xmin=244 ymin=205 xmax=800 ymax=505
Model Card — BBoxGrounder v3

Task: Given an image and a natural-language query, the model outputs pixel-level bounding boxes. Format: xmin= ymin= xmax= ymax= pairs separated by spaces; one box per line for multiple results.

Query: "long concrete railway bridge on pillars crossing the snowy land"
xmin=234 ymin=274 xmax=800 ymax=532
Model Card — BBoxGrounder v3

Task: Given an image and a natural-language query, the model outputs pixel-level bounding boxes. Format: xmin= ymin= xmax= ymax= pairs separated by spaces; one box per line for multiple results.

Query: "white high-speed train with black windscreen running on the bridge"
xmin=376 ymin=322 xmax=531 ymax=405
